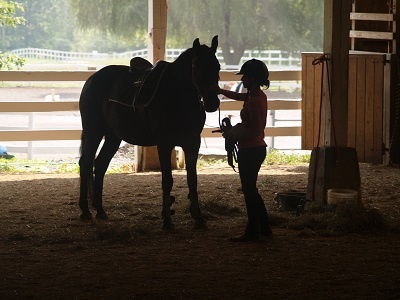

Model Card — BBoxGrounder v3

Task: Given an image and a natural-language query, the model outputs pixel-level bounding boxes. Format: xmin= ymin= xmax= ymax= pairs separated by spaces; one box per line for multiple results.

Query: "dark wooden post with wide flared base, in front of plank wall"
xmin=307 ymin=0 xmax=361 ymax=205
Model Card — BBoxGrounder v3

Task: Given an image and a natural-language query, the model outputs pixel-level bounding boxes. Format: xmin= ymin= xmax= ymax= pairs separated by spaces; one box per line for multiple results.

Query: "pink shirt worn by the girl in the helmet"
xmin=238 ymin=92 xmax=268 ymax=149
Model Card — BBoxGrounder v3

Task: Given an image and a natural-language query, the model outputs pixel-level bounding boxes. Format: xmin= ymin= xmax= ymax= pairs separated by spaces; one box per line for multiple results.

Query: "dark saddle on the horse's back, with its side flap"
xmin=109 ymin=57 xmax=169 ymax=111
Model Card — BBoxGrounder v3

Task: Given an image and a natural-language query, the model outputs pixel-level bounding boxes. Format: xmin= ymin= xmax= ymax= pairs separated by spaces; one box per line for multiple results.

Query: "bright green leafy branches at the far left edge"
xmin=0 ymin=0 xmax=25 ymax=69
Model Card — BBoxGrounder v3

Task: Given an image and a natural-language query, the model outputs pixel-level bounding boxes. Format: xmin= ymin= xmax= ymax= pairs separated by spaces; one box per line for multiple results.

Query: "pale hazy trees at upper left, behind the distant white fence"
xmin=4 ymin=0 xmax=134 ymax=52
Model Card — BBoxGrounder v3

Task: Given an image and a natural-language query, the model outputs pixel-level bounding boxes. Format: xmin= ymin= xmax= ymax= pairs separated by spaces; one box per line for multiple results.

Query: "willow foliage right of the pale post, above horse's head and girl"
xmin=168 ymin=0 xmax=323 ymax=65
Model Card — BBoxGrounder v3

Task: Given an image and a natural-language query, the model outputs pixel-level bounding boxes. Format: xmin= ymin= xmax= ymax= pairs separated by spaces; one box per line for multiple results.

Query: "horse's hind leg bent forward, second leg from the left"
xmin=93 ymin=135 xmax=121 ymax=219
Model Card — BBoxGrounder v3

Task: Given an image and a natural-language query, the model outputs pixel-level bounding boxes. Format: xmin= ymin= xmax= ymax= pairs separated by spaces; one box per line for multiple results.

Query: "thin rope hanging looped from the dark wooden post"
xmin=311 ymin=54 xmax=337 ymax=201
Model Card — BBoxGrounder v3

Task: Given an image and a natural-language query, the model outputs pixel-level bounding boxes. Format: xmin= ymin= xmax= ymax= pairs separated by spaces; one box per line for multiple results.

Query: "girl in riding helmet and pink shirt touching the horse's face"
xmin=212 ymin=59 xmax=272 ymax=242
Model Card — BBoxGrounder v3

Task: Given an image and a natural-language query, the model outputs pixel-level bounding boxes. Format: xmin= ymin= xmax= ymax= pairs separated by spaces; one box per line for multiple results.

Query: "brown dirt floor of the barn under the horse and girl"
xmin=0 ymin=164 xmax=400 ymax=299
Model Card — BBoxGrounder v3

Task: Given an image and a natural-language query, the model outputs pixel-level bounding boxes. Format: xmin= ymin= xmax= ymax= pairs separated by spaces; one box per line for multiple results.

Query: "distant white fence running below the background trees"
xmin=11 ymin=48 xmax=301 ymax=68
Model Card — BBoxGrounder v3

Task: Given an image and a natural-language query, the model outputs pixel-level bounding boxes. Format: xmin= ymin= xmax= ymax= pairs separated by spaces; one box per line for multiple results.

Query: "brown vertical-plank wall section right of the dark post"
xmin=348 ymin=55 xmax=385 ymax=163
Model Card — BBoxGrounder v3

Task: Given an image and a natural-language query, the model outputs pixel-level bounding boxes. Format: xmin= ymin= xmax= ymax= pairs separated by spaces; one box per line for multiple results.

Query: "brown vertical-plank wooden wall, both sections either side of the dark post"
xmin=301 ymin=53 xmax=386 ymax=163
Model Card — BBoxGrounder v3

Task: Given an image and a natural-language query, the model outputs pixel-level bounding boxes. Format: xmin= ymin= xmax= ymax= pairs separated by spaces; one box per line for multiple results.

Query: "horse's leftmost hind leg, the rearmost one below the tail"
xmin=79 ymin=130 xmax=103 ymax=220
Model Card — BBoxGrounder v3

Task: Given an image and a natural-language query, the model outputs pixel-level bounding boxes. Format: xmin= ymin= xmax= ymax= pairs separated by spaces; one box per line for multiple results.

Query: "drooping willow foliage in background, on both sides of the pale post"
xmin=70 ymin=0 xmax=323 ymax=65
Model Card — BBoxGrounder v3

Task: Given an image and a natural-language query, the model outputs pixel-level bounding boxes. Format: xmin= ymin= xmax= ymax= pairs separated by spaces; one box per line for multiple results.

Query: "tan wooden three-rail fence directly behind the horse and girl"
xmin=0 ymin=71 xmax=301 ymax=159
